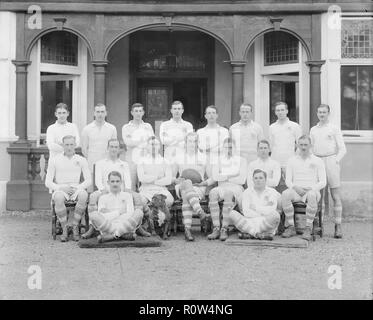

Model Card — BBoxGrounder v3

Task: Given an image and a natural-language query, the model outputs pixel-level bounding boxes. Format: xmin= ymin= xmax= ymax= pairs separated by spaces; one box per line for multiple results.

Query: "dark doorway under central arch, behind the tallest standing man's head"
xmin=137 ymin=79 xmax=207 ymax=130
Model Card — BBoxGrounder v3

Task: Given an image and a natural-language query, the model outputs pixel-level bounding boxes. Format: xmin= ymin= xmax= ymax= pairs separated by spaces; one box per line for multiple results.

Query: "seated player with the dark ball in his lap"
xmin=174 ymin=132 xmax=214 ymax=241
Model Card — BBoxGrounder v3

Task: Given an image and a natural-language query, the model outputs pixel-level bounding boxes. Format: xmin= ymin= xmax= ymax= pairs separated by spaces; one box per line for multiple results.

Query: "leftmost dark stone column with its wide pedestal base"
xmin=6 ymin=60 xmax=31 ymax=211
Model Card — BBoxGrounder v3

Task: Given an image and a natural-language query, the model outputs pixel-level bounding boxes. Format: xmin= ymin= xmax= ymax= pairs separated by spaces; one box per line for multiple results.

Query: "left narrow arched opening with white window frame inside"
xmin=27 ymin=29 xmax=92 ymax=145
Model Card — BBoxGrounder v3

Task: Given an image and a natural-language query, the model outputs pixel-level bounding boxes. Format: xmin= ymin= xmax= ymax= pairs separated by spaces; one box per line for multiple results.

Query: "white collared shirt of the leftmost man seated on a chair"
xmin=45 ymin=153 xmax=92 ymax=191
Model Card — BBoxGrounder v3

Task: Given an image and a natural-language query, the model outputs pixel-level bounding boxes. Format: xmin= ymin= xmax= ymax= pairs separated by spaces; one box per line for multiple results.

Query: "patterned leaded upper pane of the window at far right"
xmin=341 ymin=19 xmax=373 ymax=59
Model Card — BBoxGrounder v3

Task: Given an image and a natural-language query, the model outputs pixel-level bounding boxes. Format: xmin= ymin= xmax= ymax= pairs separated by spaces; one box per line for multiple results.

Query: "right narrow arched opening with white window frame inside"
xmin=245 ymin=30 xmax=309 ymax=133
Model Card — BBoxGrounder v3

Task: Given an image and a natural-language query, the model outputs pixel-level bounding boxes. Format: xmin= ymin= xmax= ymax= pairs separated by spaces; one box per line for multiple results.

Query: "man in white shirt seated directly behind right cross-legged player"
xmin=247 ymin=140 xmax=281 ymax=188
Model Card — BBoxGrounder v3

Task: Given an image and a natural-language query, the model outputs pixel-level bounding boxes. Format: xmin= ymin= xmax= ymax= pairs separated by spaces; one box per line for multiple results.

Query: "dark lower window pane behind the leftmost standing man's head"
xmin=41 ymin=80 xmax=73 ymax=133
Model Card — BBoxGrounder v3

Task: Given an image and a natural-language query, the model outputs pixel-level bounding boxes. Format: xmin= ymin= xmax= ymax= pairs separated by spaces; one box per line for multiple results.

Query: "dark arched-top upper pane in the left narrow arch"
xmin=41 ymin=31 xmax=78 ymax=66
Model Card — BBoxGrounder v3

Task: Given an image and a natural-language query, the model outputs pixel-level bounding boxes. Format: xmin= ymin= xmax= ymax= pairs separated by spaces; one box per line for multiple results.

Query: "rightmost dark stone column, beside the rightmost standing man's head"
xmin=306 ymin=60 xmax=325 ymax=128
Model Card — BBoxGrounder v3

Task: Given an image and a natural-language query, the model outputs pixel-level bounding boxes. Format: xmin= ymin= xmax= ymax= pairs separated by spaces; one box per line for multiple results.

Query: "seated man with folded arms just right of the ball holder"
xmin=207 ymin=138 xmax=247 ymax=241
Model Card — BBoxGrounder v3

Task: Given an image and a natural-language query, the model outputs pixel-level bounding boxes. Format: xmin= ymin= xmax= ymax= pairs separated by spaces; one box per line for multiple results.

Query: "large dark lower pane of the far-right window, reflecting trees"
xmin=341 ymin=66 xmax=373 ymax=130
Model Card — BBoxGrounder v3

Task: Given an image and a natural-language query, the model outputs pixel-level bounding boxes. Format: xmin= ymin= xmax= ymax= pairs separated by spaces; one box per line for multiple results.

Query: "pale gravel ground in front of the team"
xmin=0 ymin=212 xmax=373 ymax=300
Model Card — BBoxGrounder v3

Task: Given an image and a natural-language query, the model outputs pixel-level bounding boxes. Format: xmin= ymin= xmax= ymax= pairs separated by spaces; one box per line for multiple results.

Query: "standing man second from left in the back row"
xmin=81 ymin=103 xmax=117 ymax=171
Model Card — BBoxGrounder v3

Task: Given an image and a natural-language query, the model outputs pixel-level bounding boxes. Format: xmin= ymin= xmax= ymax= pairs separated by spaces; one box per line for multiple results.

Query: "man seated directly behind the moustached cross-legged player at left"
xmin=82 ymin=139 xmax=150 ymax=239
